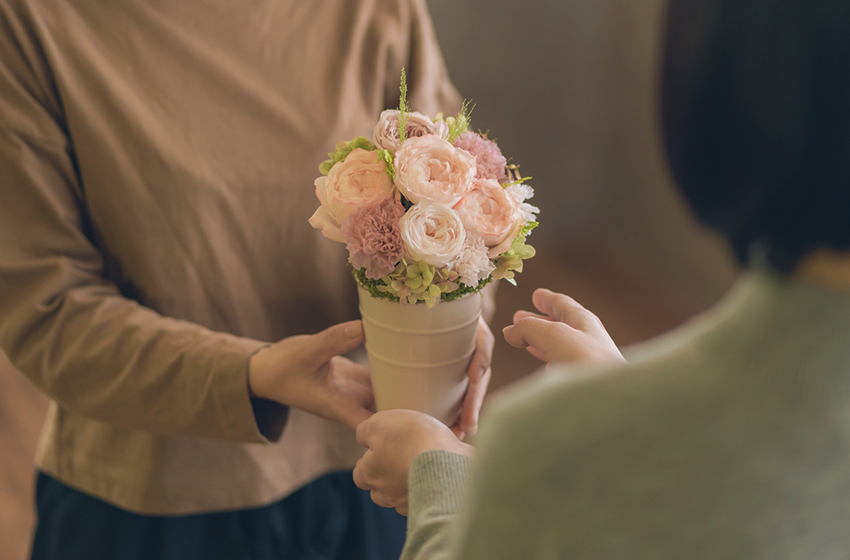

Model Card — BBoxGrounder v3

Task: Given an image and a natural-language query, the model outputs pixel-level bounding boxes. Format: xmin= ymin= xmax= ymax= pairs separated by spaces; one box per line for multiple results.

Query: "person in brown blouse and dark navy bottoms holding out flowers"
xmin=0 ymin=0 xmax=492 ymax=560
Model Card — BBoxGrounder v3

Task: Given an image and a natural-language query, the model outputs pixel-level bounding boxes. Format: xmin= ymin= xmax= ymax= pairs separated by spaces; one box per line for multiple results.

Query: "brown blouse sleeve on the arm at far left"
xmin=0 ymin=0 xmax=286 ymax=442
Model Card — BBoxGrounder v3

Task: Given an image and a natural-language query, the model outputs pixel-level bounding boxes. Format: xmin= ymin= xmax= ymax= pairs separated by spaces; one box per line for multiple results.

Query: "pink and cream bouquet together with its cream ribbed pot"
xmin=310 ymin=72 xmax=539 ymax=426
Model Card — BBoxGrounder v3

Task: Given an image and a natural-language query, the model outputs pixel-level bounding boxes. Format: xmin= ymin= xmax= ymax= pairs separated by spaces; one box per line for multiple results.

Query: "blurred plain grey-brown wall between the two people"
xmin=429 ymin=0 xmax=736 ymax=307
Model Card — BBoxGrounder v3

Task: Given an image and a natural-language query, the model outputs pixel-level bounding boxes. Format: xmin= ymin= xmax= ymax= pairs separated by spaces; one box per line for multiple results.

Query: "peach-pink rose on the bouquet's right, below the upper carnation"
xmin=454 ymin=179 xmax=522 ymax=258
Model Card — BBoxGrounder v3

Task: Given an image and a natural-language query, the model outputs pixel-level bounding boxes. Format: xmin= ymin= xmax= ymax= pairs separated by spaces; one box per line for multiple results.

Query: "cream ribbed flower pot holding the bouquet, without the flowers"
xmin=358 ymin=287 xmax=482 ymax=426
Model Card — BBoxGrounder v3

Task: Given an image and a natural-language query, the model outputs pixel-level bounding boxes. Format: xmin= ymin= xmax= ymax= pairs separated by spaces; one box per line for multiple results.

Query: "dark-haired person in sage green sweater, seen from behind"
xmin=354 ymin=0 xmax=850 ymax=560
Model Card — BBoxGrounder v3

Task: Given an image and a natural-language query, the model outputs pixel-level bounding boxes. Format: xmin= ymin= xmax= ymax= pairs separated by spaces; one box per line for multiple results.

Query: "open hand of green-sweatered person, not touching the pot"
xmin=502 ymin=288 xmax=626 ymax=364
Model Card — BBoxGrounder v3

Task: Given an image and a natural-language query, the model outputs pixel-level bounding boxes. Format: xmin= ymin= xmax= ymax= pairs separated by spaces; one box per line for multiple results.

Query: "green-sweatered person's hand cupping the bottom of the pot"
xmin=354 ymin=410 xmax=474 ymax=515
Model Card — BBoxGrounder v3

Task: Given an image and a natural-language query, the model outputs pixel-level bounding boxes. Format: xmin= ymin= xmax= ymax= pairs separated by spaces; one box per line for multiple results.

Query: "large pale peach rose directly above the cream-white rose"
xmin=395 ymin=136 xmax=475 ymax=206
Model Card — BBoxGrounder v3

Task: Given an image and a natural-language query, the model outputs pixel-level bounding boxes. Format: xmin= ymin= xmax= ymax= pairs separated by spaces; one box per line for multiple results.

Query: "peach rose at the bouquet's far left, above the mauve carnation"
xmin=310 ymin=148 xmax=395 ymax=243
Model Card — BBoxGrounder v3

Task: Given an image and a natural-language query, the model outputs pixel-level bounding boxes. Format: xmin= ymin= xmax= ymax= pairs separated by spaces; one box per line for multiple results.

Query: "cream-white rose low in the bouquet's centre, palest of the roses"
xmin=399 ymin=202 xmax=466 ymax=268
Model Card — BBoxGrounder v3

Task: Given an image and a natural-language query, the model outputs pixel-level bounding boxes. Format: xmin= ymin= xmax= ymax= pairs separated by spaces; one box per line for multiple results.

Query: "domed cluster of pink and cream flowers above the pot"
xmin=310 ymin=71 xmax=539 ymax=307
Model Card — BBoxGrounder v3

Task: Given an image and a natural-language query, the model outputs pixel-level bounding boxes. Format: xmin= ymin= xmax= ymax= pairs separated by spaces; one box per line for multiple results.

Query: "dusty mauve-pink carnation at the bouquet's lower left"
xmin=342 ymin=199 xmax=404 ymax=280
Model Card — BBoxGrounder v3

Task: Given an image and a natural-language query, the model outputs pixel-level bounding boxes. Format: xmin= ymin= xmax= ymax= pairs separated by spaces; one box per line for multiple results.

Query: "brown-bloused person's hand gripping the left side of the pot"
xmin=248 ymin=321 xmax=375 ymax=429
